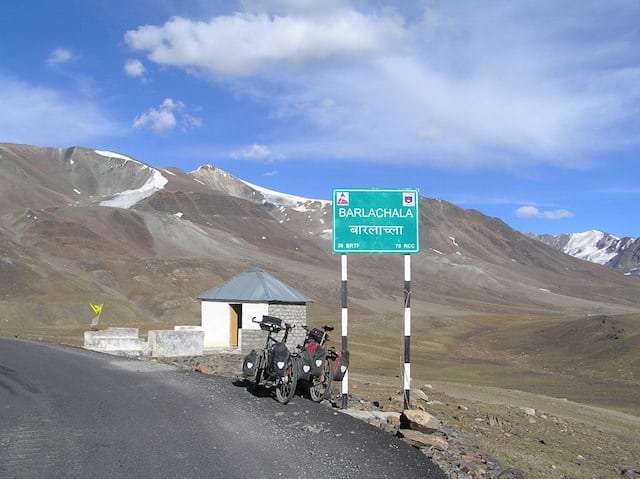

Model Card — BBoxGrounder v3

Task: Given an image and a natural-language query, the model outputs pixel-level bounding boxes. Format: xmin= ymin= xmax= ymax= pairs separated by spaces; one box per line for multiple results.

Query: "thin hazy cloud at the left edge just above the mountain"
xmin=0 ymin=75 xmax=121 ymax=146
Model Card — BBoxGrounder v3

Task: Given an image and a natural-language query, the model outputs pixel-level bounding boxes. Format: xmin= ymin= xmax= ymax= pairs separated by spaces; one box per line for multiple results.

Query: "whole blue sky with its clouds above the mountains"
xmin=0 ymin=0 xmax=640 ymax=236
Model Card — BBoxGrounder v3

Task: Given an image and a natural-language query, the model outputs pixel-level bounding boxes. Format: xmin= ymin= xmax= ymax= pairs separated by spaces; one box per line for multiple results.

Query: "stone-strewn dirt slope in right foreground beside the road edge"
xmin=350 ymin=374 xmax=640 ymax=479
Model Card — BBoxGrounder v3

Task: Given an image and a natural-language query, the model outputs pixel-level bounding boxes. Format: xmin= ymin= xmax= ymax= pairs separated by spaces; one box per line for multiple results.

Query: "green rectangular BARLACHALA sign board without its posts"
xmin=333 ymin=189 xmax=420 ymax=254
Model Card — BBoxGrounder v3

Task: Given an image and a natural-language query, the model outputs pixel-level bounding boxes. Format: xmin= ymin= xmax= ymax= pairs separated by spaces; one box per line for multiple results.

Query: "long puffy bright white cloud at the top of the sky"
xmin=125 ymin=9 xmax=404 ymax=76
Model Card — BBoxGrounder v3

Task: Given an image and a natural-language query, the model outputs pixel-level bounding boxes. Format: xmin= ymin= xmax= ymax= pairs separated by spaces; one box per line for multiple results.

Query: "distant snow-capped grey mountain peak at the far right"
xmin=533 ymin=230 xmax=640 ymax=276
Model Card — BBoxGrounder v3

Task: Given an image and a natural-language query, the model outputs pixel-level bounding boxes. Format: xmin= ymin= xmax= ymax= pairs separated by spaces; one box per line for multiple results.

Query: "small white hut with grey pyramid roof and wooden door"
xmin=198 ymin=268 xmax=311 ymax=351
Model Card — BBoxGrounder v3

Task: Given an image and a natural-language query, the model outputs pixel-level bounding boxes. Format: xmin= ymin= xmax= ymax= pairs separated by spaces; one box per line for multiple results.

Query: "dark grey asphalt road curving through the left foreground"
xmin=0 ymin=338 xmax=445 ymax=479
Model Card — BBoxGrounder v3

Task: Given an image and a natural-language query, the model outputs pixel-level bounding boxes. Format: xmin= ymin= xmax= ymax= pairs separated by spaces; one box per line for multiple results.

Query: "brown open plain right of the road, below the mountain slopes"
xmin=338 ymin=316 xmax=640 ymax=478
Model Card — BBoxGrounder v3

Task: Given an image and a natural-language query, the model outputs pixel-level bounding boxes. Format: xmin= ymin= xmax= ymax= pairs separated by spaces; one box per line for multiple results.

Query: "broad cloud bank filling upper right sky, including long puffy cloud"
xmin=125 ymin=0 xmax=640 ymax=167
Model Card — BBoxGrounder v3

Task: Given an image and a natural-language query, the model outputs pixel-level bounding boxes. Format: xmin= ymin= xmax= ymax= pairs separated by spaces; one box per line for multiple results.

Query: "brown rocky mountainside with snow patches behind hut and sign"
xmin=0 ymin=144 xmax=640 ymax=337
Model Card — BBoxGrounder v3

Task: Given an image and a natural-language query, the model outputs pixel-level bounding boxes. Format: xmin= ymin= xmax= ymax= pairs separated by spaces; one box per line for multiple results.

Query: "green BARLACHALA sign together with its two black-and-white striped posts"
xmin=332 ymin=188 xmax=420 ymax=409
